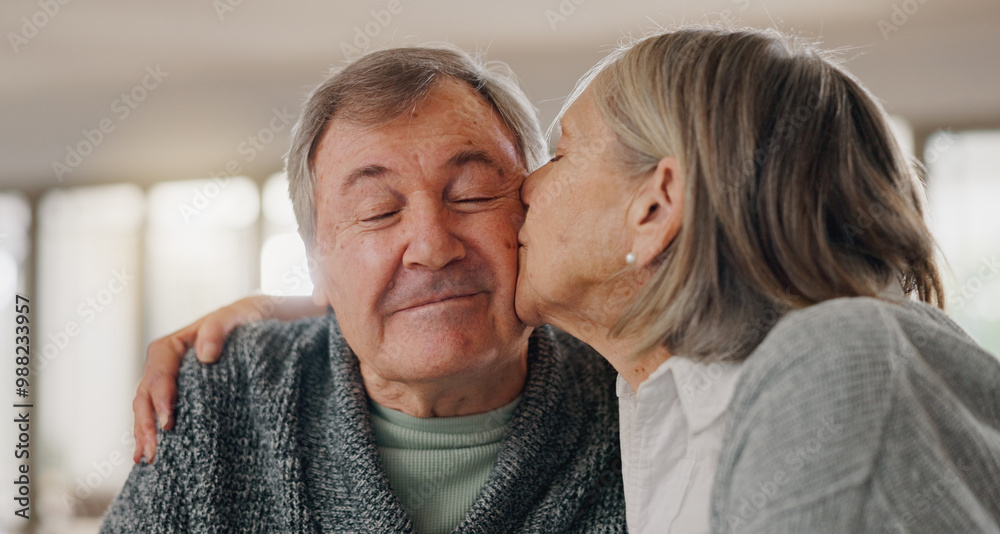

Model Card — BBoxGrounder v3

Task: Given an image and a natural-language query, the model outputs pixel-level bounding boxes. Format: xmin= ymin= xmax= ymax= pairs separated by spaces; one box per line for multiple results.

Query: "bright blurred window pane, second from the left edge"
xmin=31 ymin=184 xmax=145 ymax=517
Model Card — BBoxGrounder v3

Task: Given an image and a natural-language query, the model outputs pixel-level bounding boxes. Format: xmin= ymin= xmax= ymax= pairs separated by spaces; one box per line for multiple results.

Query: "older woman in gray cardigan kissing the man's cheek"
xmin=136 ymin=29 xmax=1000 ymax=533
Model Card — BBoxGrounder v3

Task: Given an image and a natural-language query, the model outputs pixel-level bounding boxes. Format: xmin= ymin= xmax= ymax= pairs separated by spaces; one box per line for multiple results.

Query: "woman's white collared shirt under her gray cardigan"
xmin=618 ymin=356 xmax=741 ymax=534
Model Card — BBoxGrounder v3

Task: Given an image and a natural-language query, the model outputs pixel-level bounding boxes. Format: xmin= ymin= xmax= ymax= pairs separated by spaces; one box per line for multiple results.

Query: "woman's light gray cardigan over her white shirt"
xmin=711 ymin=298 xmax=1000 ymax=534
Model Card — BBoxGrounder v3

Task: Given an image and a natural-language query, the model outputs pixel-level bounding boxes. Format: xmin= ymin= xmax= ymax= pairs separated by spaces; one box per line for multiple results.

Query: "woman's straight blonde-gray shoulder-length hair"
xmin=576 ymin=28 xmax=944 ymax=359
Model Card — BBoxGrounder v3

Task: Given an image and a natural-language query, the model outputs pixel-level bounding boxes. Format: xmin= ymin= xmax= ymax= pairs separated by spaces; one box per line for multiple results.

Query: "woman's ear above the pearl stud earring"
xmin=627 ymin=157 xmax=685 ymax=269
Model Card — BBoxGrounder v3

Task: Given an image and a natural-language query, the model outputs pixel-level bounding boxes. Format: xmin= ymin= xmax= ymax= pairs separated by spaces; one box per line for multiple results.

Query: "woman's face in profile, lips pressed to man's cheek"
xmin=515 ymin=90 xmax=629 ymax=329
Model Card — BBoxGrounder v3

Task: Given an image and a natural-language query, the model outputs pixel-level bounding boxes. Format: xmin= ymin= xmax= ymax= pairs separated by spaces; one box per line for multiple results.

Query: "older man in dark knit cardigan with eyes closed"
xmin=102 ymin=48 xmax=625 ymax=533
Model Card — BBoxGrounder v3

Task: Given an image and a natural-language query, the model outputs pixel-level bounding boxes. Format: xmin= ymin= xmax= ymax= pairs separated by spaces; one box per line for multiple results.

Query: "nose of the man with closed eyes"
xmin=403 ymin=202 xmax=465 ymax=270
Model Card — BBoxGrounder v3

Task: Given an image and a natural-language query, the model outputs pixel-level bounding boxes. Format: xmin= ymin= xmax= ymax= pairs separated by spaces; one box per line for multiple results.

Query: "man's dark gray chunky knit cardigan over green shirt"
xmin=101 ymin=315 xmax=625 ymax=534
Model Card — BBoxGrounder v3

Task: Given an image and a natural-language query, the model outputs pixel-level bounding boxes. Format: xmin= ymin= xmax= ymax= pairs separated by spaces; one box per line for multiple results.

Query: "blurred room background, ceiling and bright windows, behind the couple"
xmin=0 ymin=0 xmax=1000 ymax=533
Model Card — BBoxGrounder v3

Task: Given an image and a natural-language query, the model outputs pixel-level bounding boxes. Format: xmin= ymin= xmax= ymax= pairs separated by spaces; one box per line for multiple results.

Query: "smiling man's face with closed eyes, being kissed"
xmin=312 ymin=80 xmax=530 ymax=388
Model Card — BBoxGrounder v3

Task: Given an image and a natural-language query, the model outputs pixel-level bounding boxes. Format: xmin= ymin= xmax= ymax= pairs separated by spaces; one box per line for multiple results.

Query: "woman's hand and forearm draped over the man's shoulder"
xmin=132 ymin=295 xmax=326 ymax=463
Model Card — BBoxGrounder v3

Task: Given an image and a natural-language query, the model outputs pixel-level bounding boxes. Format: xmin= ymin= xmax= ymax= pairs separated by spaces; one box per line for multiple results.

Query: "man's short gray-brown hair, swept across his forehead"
xmin=286 ymin=47 xmax=547 ymax=249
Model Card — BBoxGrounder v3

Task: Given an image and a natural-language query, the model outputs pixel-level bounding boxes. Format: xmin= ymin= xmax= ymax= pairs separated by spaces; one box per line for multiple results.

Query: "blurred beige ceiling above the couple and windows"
xmin=0 ymin=0 xmax=1000 ymax=196
